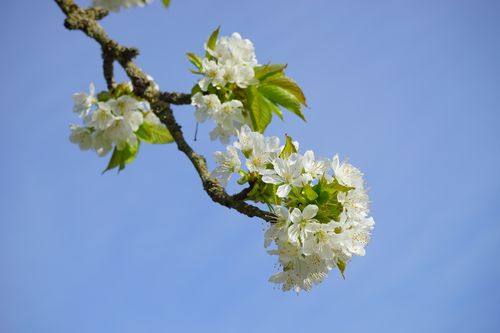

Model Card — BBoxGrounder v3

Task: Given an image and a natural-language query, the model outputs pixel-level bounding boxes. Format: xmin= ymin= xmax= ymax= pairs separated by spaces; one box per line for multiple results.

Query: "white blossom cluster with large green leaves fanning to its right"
xmin=187 ymin=29 xmax=306 ymax=144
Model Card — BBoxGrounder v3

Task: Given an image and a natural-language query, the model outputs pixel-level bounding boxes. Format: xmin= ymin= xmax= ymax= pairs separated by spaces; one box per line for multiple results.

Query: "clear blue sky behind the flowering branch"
xmin=0 ymin=0 xmax=500 ymax=333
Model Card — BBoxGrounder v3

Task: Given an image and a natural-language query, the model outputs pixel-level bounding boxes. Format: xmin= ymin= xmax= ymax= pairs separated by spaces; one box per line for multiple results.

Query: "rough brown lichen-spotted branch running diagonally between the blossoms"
xmin=55 ymin=0 xmax=276 ymax=222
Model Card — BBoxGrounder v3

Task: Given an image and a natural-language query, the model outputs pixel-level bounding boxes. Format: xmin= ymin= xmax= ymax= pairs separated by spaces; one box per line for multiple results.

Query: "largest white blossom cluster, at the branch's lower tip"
xmin=212 ymin=126 xmax=374 ymax=292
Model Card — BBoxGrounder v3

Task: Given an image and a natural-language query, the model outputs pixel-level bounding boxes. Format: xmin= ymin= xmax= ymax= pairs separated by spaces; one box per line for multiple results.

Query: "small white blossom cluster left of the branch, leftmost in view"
xmin=70 ymin=83 xmax=166 ymax=163
